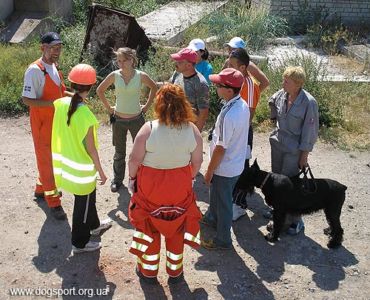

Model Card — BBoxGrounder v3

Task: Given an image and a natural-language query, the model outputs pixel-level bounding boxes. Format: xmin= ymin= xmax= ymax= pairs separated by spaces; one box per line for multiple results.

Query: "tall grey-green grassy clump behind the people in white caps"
xmin=187 ymin=4 xmax=288 ymax=51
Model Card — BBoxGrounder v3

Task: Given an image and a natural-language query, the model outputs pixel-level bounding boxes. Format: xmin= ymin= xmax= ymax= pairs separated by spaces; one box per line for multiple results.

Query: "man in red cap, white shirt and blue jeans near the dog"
xmin=201 ymin=68 xmax=250 ymax=250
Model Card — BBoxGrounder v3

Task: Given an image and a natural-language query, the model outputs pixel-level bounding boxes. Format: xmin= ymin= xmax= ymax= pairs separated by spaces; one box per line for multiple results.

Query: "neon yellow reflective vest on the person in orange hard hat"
xmin=51 ymin=97 xmax=99 ymax=195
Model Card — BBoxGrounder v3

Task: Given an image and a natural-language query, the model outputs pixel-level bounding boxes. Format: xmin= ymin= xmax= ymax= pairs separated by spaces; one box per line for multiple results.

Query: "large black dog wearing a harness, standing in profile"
xmin=244 ymin=160 xmax=347 ymax=248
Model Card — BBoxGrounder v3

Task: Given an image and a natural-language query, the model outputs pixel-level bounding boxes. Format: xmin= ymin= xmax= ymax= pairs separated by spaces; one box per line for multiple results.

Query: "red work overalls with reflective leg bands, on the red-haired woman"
xmin=129 ymin=166 xmax=201 ymax=277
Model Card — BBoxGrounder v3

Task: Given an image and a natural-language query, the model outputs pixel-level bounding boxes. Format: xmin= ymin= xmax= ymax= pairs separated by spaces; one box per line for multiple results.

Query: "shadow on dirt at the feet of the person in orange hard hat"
xmin=32 ymin=201 xmax=116 ymax=299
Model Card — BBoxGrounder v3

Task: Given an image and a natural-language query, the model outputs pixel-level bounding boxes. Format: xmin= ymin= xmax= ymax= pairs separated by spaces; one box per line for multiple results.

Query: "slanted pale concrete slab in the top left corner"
xmin=0 ymin=11 xmax=52 ymax=43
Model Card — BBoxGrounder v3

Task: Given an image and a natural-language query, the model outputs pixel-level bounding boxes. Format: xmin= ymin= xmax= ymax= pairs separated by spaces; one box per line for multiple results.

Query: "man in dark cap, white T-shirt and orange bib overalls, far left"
xmin=22 ymin=32 xmax=66 ymax=220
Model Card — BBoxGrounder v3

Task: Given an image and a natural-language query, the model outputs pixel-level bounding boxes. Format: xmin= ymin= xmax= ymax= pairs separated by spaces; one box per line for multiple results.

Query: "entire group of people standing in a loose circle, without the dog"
xmin=22 ymin=32 xmax=318 ymax=283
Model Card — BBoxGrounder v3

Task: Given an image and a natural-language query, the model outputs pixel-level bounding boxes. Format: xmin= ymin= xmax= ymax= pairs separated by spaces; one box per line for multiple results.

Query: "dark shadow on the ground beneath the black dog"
xmin=233 ymin=194 xmax=358 ymax=291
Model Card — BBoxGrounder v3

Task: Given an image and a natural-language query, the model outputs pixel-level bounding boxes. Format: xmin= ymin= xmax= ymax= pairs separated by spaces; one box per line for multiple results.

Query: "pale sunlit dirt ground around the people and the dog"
xmin=0 ymin=117 xmax=370 ymax=300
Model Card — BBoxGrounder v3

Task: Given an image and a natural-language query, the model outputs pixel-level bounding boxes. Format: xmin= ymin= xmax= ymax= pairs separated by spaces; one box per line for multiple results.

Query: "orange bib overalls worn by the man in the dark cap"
xmin=30 ymin=59 xmax=65 ymax=207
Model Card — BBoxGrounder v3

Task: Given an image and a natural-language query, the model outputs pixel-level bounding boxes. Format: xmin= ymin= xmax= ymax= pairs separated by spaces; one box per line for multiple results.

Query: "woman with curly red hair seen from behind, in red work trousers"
xmin=128 ymin=84 xmax=203 ymax=283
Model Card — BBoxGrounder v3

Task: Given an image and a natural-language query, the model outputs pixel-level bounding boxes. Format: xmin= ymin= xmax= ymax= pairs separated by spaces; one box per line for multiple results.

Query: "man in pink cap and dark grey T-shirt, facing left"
xmin=169 ymin=48 xmax=209 ymax=131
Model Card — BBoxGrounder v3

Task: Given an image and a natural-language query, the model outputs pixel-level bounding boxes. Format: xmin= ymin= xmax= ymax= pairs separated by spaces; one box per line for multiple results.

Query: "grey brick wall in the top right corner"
xmin=252 ymin=0 xmax=370 ymax=26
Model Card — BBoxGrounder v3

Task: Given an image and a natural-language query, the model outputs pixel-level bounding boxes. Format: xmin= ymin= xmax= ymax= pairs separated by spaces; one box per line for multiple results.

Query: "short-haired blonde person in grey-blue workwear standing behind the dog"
xmin=269 ymin=66 xmax=319 ymax=235
